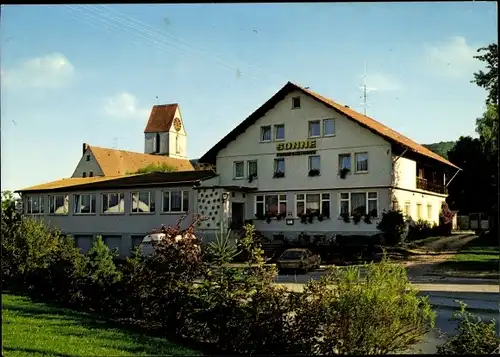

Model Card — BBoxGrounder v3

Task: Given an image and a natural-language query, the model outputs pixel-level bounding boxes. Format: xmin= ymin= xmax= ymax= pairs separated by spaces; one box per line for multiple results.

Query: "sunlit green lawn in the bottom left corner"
xmin=2 ymin=294 xmax=201 ymax=357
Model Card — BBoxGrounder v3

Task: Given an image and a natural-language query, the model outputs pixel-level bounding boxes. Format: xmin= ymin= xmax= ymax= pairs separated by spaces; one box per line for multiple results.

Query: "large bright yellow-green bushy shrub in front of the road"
xmin=288 ymin=260 xmax=435 ymax=355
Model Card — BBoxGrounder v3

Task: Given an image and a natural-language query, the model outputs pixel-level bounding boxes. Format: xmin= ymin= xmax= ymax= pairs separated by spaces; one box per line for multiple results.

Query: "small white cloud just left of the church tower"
xmin=103 ymin=92 xmax=150 ymax=120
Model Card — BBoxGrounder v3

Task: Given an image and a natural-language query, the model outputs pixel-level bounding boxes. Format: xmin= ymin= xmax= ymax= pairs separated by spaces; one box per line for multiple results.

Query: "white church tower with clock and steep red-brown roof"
xmin=144 ymin=103 xmax=187 ymax=159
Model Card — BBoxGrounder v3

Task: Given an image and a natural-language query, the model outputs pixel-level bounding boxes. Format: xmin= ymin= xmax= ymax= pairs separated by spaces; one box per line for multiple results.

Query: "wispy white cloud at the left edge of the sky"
xmin=1 ymin=53 xmax=75 ymax=89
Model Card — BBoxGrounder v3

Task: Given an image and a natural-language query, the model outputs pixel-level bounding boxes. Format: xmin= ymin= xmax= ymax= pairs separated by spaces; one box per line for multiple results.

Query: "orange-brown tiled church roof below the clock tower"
xmin=89 ymin=145 xmax=194 ymax=176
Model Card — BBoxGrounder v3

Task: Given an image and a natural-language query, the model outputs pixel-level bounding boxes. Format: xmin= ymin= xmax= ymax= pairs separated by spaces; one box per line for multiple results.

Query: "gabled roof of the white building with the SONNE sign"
xmin=199 ymin=82 xmax=458 ymax=169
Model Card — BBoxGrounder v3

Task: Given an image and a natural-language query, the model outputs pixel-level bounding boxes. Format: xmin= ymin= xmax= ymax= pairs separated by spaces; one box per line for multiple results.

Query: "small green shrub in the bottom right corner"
xmin=437 ymin=301 xmax=500 ymax=355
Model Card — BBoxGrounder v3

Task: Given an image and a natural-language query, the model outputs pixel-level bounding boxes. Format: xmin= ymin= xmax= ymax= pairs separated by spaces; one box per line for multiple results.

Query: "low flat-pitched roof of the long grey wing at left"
xmin=16 ymin=170 xmax=217 ymax=193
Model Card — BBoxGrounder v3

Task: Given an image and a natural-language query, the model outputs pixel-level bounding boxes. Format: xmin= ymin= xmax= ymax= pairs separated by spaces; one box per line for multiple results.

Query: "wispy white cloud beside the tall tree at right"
xmin=426 ymin=36 xmax=481 ymax=78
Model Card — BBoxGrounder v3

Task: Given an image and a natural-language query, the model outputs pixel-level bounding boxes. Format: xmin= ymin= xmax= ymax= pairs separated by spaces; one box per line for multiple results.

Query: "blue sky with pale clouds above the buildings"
xmin=0 ymin=2 xmax=497 ymax=190
